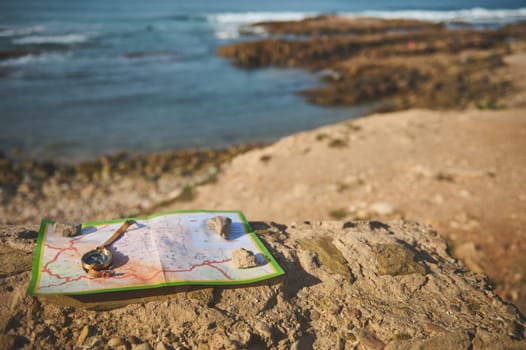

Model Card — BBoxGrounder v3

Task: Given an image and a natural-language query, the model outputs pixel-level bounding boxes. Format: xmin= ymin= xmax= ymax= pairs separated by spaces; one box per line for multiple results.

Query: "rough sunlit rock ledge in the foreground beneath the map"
xmin=0 ymin=221 xmax=526 ymax=349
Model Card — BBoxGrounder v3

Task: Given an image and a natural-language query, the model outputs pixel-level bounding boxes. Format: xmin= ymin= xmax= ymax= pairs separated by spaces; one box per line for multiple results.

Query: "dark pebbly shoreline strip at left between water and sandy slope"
xmin=0 ymin=144 xmax=261 ymax=224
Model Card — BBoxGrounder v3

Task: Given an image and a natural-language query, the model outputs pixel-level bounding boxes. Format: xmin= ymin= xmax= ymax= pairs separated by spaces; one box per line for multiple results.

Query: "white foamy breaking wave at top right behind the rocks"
xmin=341 ymin=7 xmax=526 ymax=23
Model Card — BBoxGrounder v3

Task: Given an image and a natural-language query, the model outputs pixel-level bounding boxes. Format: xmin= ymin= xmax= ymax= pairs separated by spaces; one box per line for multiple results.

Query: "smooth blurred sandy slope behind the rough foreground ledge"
xmin=167 ymin=109 xmax=526 ymax=310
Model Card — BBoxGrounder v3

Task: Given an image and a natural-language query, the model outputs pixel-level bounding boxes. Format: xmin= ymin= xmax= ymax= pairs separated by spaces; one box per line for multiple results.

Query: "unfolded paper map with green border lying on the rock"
xmin=28 ymin=211 xmax=284 ymax=295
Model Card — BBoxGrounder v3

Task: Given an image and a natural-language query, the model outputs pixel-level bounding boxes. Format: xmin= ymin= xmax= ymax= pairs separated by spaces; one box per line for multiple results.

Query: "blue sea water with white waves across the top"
xmin=0 ymin=0 xmax=526 ymax=161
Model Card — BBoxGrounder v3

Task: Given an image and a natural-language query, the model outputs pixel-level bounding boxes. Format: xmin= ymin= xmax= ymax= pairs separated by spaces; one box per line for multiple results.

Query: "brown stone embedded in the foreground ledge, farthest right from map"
xmin=373 ymin=244 xmax=426 ymax=276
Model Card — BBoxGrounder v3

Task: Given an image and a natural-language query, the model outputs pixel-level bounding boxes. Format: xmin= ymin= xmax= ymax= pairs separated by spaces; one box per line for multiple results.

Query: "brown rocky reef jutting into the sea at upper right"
xmin=217 ymin=15 xmax=526 ymax=110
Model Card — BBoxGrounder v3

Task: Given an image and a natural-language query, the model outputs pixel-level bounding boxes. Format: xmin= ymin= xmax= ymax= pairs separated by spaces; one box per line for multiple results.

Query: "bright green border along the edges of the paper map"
xmin=27 ymin=210 xmax=285 ymax=296
